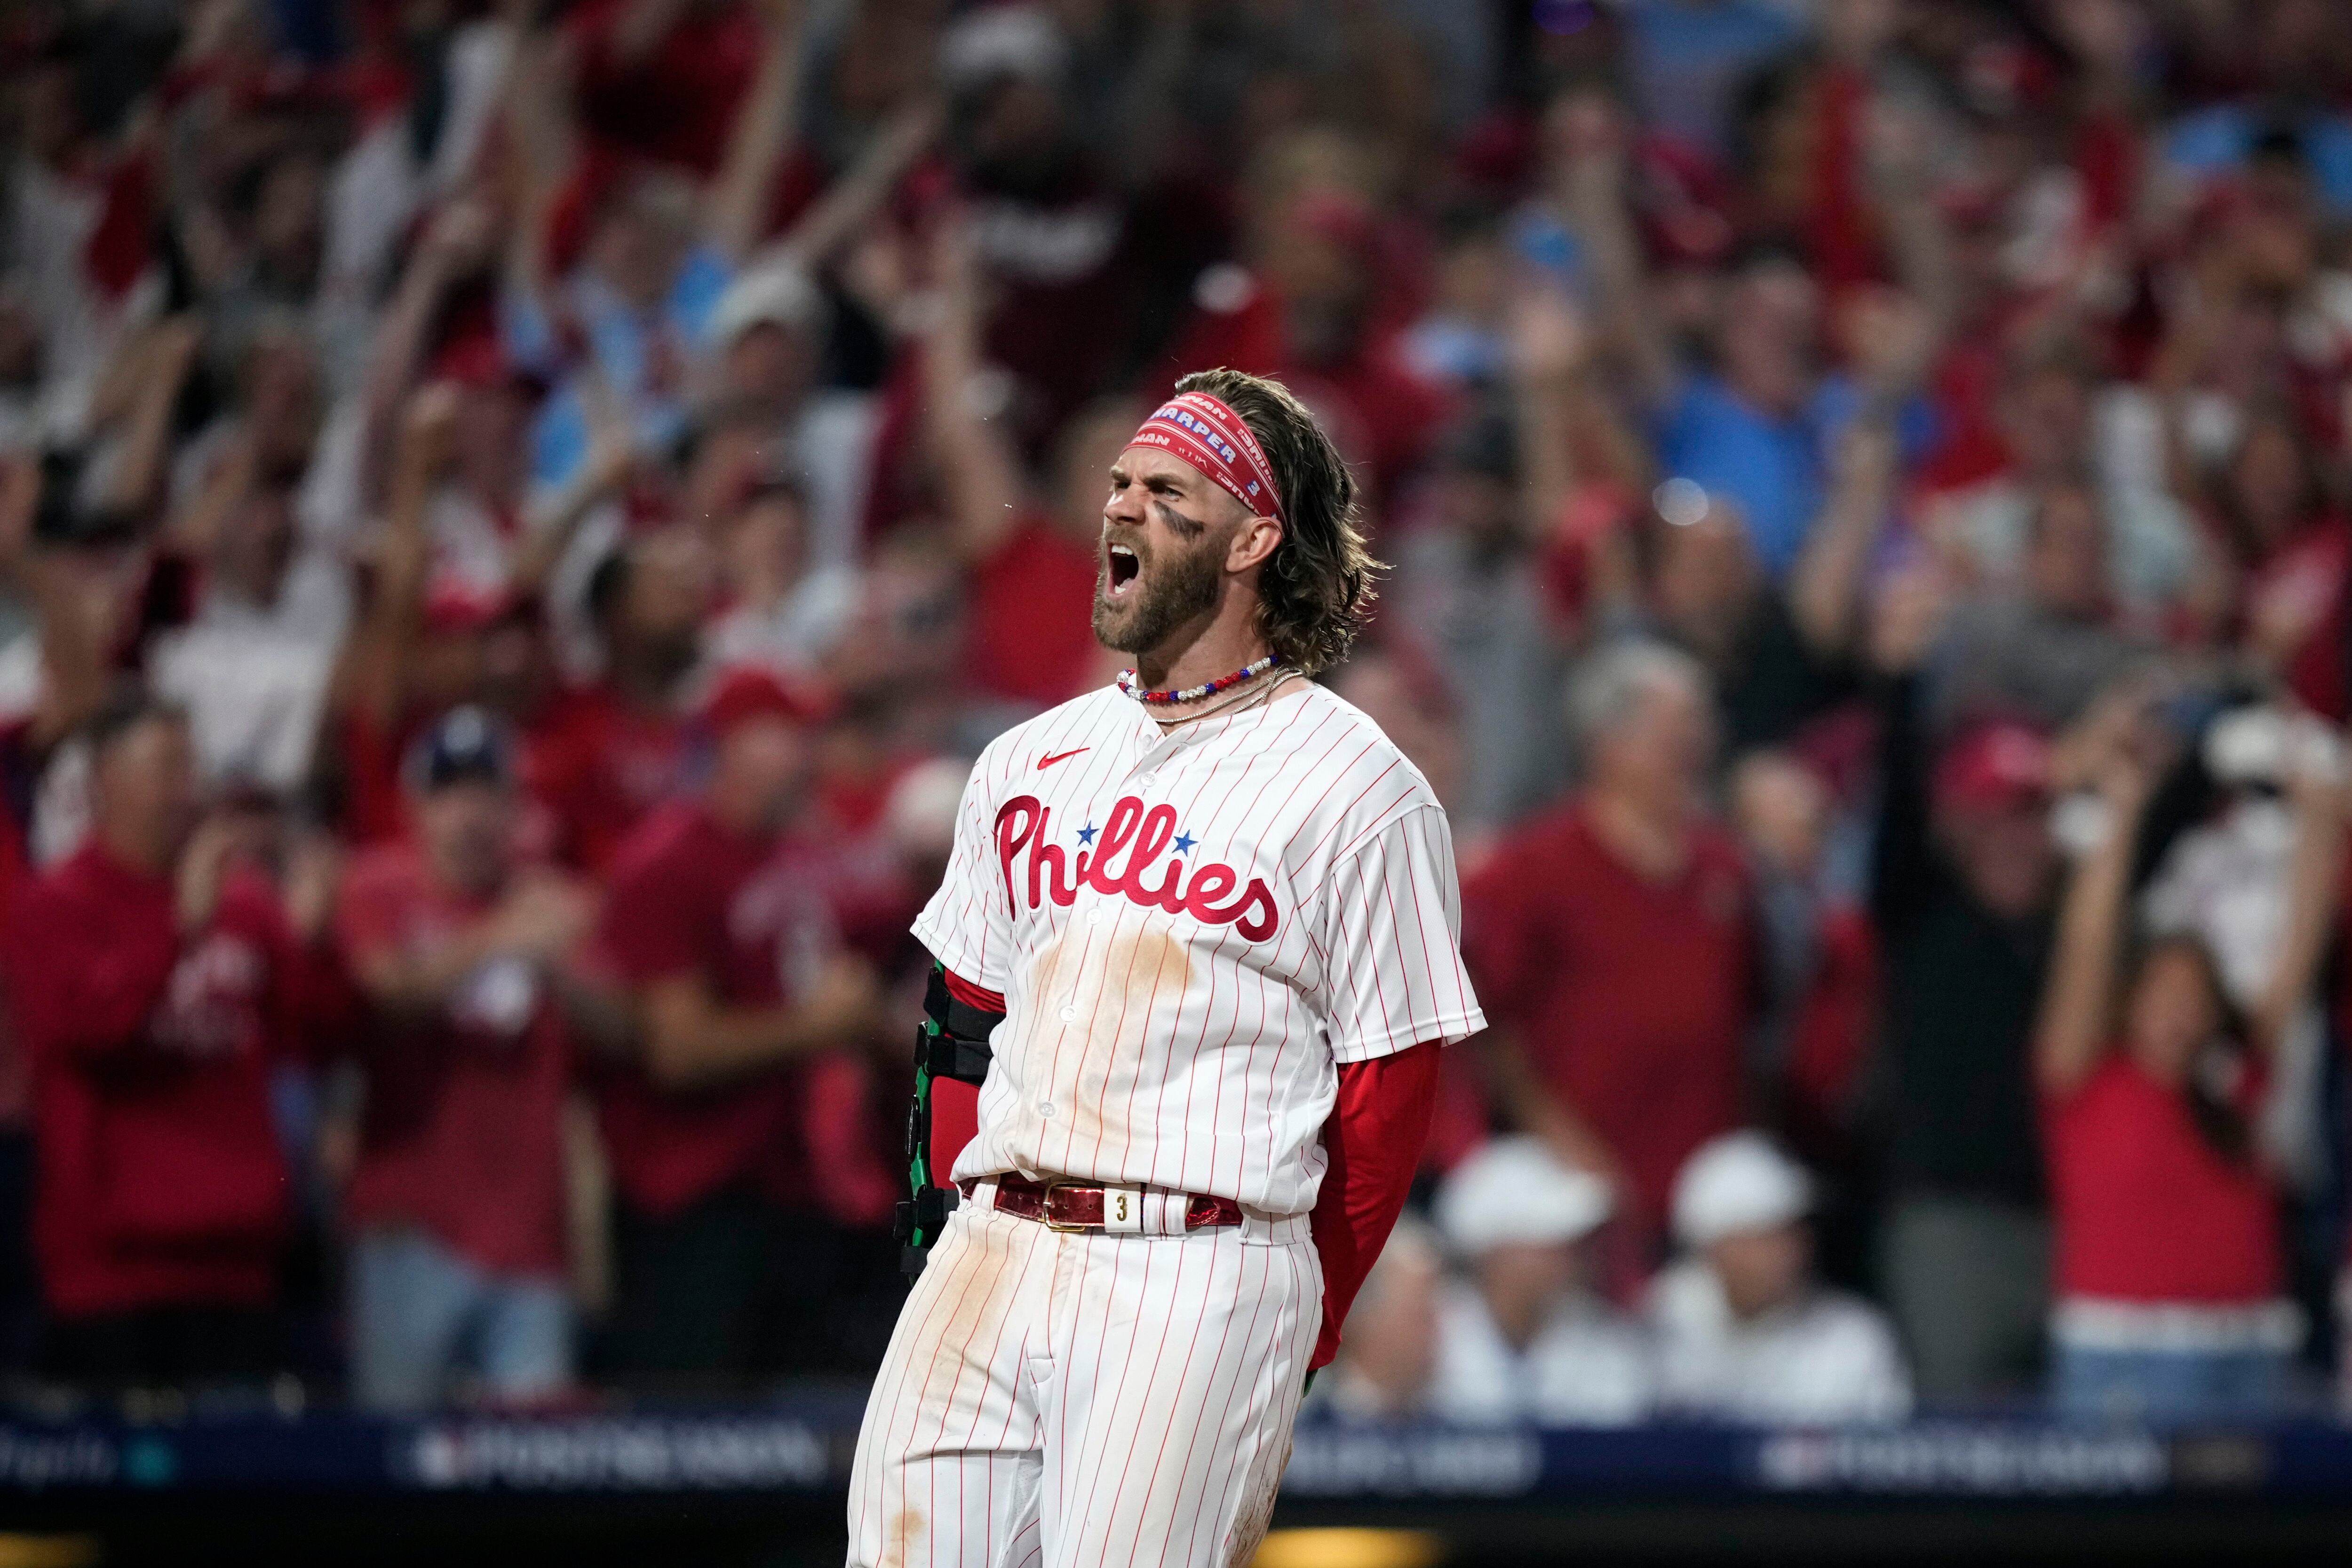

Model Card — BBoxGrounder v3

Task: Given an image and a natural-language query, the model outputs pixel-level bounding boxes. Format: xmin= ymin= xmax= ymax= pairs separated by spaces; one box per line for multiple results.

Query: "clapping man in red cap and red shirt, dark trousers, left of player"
xmin=595 ymin=670 xmax=880 ymax=1380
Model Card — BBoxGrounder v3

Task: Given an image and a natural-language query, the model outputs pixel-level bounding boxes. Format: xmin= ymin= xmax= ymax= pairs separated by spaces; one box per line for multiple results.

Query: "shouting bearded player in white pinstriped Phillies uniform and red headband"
xmin=849 ymin=372 xmax=1484 ymax=1568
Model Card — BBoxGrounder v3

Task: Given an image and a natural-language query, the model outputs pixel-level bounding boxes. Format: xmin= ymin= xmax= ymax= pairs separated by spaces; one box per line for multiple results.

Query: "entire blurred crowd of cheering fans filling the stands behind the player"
xmin=0 ymin=0 xmax=2352 ymax=1422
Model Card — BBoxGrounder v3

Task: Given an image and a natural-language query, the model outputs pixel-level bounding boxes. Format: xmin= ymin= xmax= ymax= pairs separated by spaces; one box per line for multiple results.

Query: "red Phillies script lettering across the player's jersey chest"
xmin=997 ymin=794 xmax=1282 ymax=942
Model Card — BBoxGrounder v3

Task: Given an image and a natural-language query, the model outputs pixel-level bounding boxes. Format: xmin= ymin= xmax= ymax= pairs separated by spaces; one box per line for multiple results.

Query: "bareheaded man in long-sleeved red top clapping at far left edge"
xmin=7 ymin=696 xmax=325 ymax=1387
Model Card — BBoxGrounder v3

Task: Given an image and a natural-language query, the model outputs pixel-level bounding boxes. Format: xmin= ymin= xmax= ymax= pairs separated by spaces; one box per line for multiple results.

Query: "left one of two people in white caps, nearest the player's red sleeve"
xmin=1430 ymin=1135 xmax=1658 ymax=1427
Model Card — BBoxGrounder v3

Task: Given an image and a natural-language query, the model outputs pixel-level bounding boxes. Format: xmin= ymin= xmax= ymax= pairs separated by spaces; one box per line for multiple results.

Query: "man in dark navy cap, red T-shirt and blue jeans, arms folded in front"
xmin=336 ymin=708 xmax=593 ymax=1408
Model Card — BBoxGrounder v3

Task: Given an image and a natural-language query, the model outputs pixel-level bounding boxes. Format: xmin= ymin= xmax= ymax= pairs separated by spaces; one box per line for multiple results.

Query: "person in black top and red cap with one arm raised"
xmin=1870 ymin=597 xmax=2058 ymax=1399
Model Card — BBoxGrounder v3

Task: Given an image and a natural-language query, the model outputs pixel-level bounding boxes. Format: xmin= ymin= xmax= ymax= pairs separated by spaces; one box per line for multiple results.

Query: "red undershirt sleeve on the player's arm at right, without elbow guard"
xmin=1308 ymin=1039 xmax=1439 ymax=1368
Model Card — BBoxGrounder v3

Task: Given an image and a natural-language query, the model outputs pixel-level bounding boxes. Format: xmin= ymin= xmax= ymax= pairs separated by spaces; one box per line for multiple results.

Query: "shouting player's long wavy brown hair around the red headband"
xmin=1176 ymin=369 xmax=1388 ymax=675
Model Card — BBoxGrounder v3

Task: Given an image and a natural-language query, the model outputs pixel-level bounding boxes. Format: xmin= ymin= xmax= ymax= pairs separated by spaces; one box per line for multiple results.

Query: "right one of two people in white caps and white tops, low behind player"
xmin=1649 ymin=1133 xmax=1912 ymax=1425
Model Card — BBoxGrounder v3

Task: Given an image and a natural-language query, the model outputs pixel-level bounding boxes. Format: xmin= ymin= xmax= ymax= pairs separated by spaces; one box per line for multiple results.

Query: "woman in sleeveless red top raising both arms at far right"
xmin=2034 ymin=719 xmax=2345 ymax=1420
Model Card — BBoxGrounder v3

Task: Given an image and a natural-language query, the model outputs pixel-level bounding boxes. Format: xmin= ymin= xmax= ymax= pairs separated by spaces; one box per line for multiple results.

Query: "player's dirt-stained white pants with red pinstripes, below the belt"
xmin=849 ymin=1201 xmax=1322 ymax=1568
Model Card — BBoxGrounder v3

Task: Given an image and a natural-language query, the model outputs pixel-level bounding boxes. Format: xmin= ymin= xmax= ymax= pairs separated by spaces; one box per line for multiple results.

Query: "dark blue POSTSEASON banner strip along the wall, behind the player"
xmin=0 ymin=1401 xmax=2352 ymax=1502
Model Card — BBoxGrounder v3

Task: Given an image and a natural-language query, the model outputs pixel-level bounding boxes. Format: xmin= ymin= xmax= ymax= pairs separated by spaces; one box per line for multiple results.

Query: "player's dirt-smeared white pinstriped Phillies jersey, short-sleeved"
xmin=915 ymin=687 xmax=1484 ymax=1215
